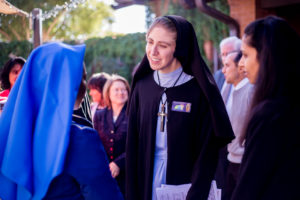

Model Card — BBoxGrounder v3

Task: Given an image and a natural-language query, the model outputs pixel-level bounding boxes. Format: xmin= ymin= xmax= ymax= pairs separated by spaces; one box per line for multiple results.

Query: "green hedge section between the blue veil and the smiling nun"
xmin=85 ymin=33 xmax=145 ymax=81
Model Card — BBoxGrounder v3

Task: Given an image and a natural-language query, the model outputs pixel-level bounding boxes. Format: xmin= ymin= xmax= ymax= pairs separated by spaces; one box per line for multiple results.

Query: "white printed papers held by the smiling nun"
xmin=156 ymin=180 xmax=221 ymax=200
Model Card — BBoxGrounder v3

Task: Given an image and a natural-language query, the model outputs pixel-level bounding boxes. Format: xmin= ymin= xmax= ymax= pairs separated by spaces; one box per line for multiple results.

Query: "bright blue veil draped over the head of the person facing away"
xmin=0 ymin=43 xmax=85 ymax=200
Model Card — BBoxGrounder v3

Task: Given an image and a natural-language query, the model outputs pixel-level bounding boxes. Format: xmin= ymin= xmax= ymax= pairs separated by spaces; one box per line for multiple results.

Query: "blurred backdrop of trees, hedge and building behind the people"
xmin=0 ymin=0 xmax=300 ymax=80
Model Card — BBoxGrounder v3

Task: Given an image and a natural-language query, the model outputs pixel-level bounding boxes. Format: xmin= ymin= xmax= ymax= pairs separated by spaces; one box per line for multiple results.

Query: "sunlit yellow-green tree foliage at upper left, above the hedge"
xmin=0 ymin=0 xmax=113 ymax=41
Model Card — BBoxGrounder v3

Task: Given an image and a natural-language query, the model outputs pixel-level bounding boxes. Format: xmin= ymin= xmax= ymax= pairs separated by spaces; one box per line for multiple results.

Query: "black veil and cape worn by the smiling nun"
xmin=126 ymin=16 xmax=233 ymax=200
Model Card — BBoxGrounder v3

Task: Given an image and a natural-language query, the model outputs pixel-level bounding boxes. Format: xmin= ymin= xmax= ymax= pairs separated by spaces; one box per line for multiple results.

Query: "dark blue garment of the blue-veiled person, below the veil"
xmin=43 ymin=119 xmax=123 ymax=200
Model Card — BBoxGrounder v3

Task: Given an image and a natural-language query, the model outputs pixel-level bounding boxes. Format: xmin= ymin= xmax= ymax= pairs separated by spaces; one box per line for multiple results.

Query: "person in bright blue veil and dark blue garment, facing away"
xmin=0 ymin=43 xmax=123 ymax=200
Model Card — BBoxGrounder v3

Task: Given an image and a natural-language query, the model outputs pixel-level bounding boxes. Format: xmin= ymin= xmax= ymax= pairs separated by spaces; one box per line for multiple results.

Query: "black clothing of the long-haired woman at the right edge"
xmin=232 ymin=98 xmax=300 ymax=200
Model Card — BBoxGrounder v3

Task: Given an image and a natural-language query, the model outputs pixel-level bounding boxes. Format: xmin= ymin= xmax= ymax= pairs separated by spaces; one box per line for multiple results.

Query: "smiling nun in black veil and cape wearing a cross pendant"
xmin=126 ymin=15 xmax=233 ymax=200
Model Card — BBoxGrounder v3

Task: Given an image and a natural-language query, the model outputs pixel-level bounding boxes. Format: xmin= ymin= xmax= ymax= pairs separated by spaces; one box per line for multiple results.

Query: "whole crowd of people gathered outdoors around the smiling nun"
xmin=0 ymin=15 xmax=300 ymax=200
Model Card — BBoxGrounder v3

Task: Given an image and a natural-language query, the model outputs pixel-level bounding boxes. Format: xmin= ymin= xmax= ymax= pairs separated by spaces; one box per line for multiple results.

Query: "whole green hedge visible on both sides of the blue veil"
xmin=0 ymin=33 xmax=145 ymax=81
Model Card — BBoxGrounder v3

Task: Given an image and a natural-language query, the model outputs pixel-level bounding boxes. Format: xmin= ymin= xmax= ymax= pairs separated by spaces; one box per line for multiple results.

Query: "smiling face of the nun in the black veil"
xmin=146 ymin=26 xmax=180 ymax=73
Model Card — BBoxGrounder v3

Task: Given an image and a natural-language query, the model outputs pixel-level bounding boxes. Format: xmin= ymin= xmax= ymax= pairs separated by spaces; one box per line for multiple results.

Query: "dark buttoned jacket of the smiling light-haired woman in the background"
xmin=94 ymin=104 xmax=128 ymax=194
